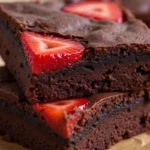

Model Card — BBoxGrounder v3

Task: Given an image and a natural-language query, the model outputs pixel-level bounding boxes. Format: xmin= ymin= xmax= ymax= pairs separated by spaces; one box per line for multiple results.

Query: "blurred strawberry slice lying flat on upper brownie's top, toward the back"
xmin=63 ymin=1 xmax=123 ymax=23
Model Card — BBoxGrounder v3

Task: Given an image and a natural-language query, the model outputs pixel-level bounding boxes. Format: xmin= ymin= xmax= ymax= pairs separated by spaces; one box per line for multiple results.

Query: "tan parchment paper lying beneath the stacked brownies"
xmin=0 ymin=0 xmax=150 ymax=150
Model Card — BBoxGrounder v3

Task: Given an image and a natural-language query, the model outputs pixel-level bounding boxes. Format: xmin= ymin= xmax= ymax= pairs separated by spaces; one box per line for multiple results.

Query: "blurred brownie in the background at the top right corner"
xmin=122 ymin=0 xmax=150 ymax=27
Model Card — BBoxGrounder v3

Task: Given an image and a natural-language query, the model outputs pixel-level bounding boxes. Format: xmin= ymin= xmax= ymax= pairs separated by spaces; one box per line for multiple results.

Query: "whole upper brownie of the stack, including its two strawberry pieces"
xmin=0 ymin=1 xmax=150 ymax=103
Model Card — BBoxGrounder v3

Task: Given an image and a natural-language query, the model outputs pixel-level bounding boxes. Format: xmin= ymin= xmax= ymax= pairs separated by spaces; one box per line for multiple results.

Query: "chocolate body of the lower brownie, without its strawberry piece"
xmin=0 ymin=68 xmax=150 ymax=150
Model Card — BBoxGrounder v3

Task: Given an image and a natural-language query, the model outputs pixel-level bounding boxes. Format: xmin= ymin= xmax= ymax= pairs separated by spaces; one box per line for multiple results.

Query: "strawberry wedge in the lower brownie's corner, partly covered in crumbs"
xmin=33 ymin=98 xmax=89 ymax=139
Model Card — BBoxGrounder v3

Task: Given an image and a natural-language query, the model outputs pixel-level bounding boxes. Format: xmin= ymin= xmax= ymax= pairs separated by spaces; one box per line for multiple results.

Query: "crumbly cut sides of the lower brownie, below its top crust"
xmin=0 ymin=93 xmax=150 ymax=150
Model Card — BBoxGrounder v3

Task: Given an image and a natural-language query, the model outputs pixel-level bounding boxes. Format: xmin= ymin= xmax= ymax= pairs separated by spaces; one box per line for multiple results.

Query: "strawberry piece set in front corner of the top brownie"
xmin=21 ymin=32 xmax=84 ymax=74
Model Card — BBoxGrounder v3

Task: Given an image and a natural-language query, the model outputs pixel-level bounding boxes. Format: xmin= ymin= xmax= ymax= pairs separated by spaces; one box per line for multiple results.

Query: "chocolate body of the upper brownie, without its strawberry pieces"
xmin=0 ymin=1 xmax=150 ymax=103
